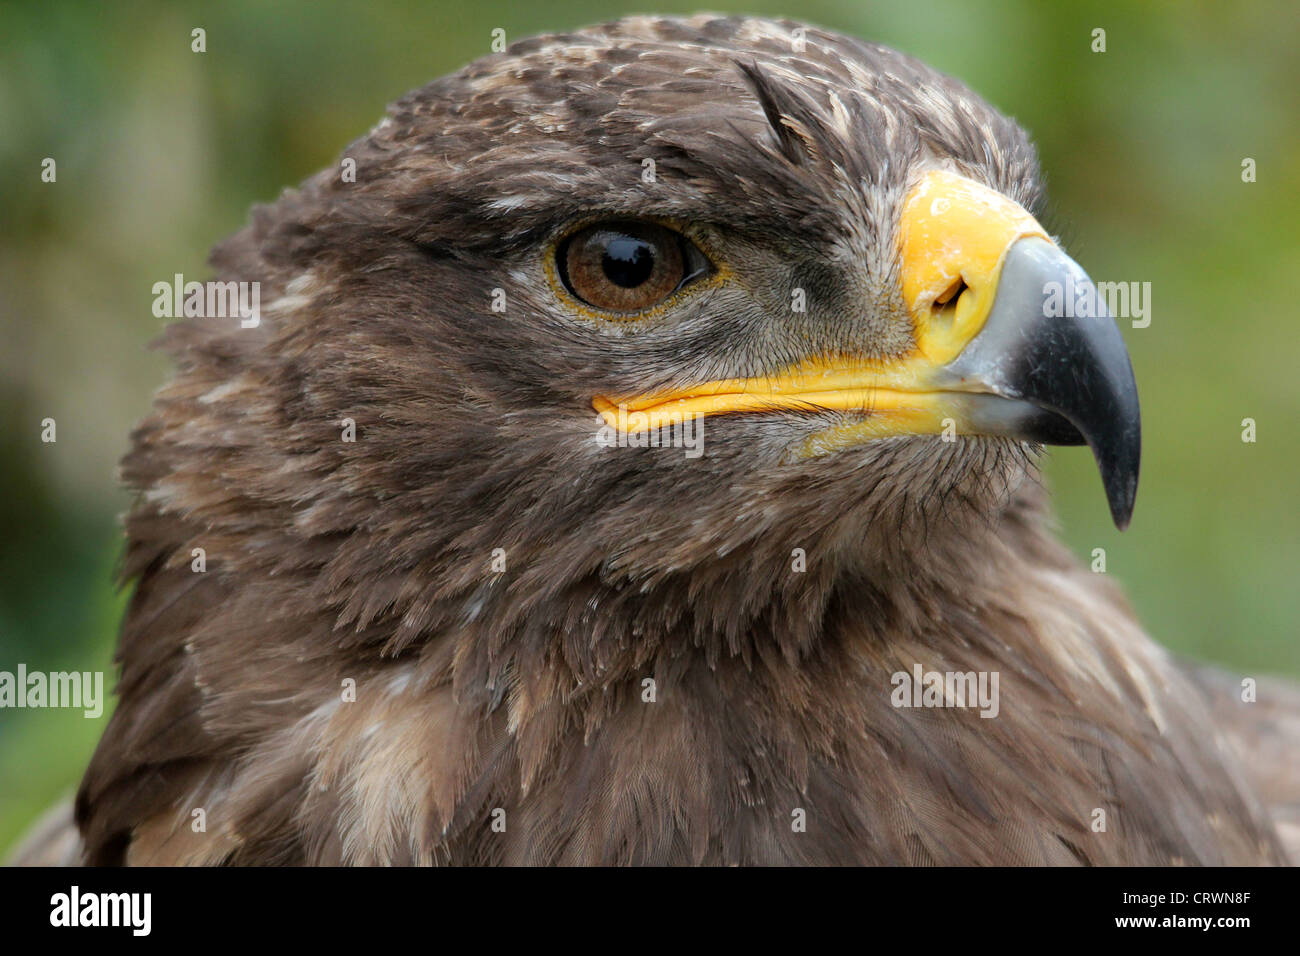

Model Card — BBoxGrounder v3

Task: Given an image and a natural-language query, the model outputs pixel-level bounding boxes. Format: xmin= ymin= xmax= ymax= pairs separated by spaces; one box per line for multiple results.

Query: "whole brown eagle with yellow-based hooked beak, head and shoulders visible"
xmin=12 ymin=16 xmax=1300 ymax=865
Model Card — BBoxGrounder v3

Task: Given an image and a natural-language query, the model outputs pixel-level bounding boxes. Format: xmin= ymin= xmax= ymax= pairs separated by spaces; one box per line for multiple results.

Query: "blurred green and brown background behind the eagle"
xmin=0 ymin=0 xmax=1300 ymax=848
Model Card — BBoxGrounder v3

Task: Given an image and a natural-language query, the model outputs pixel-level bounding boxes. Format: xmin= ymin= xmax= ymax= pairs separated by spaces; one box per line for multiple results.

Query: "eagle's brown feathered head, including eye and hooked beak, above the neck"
xmin=175 ymin=17 xmax=1139 ymax=671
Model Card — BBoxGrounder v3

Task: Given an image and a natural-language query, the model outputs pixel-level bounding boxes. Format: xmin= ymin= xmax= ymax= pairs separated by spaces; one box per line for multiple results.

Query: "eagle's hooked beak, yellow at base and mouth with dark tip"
xmin=593 ymin=170 xmax=1141 ymax=529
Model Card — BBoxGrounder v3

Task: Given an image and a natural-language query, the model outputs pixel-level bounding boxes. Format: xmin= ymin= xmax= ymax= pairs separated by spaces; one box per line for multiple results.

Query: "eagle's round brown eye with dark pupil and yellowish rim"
xmin=556 ymin=222 xmax=709 ymax=313
